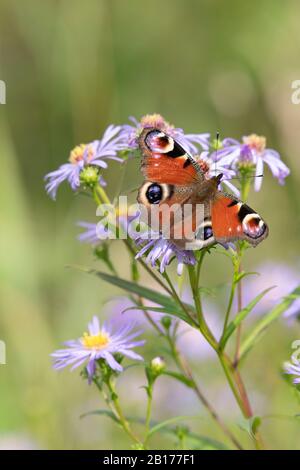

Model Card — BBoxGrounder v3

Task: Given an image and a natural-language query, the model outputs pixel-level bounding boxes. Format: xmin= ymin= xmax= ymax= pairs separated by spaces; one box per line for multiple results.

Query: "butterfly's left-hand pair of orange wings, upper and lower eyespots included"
xmin=137 ymin=128 xmax=209 ymax=243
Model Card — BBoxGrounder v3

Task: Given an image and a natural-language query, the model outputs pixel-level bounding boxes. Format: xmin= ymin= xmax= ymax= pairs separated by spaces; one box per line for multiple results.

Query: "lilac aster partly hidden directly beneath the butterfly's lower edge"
xmin=135 ymin=235 xmax=196 ymax=276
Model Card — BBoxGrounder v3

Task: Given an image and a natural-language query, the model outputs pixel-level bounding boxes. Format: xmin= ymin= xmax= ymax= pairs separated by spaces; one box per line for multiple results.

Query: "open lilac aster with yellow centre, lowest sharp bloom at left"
xmin=51 ymin=316 xmax=145 ymax=383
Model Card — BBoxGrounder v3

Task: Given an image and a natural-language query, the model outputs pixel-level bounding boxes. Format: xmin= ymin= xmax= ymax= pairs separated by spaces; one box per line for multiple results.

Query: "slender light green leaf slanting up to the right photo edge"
xmin=240 ymin=286 xmax=300 ymax=358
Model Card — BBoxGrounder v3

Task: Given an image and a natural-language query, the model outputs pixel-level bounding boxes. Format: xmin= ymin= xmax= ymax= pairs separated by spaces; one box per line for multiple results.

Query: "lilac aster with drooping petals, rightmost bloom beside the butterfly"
xmin=211 ymin=134 xmax=290 ymax=191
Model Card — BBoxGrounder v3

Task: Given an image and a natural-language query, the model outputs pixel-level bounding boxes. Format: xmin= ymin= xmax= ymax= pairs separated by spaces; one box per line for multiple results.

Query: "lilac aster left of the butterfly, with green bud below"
xmin=45 ymin=125 xmax=124 ymax=199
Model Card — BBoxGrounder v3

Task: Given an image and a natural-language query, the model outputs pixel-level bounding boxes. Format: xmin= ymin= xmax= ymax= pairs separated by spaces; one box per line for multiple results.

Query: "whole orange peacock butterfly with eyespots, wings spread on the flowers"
xmin=137 ymin=128 xmax=268 ymax=249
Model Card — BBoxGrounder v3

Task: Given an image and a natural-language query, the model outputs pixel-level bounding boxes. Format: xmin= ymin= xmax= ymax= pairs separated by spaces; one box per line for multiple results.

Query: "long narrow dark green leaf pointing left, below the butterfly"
xmin=83 ymin=268 xmax=195 ymax=326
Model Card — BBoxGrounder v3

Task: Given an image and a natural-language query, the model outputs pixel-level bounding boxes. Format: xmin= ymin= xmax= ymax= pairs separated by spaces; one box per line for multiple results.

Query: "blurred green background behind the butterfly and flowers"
xmin=0 ymin=0 xmax=300 ymax=449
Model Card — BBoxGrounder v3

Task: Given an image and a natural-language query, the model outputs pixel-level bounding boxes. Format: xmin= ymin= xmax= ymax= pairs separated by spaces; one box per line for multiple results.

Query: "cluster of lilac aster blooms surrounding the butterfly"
xmin=45 ymin=114 xmax=289 ymax=274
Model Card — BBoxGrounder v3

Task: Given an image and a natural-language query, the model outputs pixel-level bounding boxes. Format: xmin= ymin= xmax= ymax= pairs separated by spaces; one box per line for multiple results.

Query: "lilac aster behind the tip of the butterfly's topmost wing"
xmin=121 ymin=114 xmax=210 ymax=154
